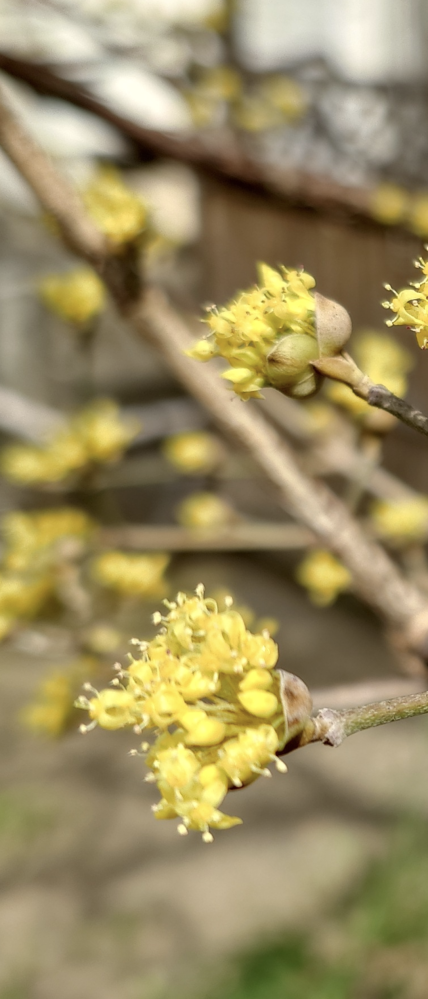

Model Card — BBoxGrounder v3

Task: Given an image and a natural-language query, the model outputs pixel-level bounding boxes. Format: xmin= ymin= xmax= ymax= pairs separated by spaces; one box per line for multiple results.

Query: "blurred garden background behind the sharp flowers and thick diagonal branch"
xmin=0 ymin=0 xmax=428 ymax=999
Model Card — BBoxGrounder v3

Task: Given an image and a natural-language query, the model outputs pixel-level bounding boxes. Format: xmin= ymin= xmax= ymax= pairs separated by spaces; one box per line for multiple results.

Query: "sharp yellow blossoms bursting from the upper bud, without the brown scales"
xmin=188 ymin=264 xmax=318 ymax=400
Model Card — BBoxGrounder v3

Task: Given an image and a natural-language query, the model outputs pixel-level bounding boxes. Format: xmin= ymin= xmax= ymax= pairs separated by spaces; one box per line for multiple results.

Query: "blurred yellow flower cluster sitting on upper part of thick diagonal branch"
xmin=83 ymin=166 xmax=147 ymax=247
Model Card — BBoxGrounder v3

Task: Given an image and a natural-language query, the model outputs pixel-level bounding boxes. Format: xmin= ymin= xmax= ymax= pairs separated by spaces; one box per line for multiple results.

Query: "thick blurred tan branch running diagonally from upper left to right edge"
xmin=0 ymin=84 xmax=428 ymax=653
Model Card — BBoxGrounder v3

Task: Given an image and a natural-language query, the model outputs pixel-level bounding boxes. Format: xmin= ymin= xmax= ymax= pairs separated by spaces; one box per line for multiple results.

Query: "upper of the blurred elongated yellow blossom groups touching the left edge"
xmin=0 ymin=399 xmax=139 ymax=485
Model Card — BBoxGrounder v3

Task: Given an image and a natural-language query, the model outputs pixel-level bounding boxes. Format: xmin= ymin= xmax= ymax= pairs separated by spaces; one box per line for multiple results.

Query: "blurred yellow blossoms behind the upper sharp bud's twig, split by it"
xmin=325 ymin=330 xmax=413 ymax=432
